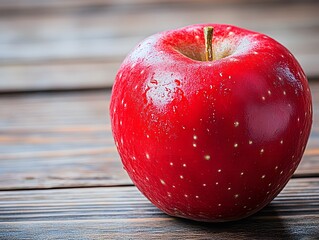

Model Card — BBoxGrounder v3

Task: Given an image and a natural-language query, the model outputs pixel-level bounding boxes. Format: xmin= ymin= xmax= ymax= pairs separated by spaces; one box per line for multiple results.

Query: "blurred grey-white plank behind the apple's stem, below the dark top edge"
xmin=0 ymin=3 xmax=319 ymax=63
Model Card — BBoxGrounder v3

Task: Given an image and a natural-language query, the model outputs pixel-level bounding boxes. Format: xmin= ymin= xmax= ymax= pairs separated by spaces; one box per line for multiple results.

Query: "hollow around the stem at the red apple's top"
xmin=162 ymin=24 xmax=264 ymax=61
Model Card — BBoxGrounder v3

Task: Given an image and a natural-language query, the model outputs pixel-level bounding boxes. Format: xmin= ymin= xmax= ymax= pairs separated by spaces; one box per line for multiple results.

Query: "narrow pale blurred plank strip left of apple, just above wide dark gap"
xmin=0 ymin=60 xmax=120 ymax=92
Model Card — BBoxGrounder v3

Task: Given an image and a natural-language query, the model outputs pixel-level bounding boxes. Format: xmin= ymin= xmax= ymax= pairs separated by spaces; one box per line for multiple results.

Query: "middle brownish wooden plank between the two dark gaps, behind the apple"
xmin=0 ymin=82 xmax=319 ymax=189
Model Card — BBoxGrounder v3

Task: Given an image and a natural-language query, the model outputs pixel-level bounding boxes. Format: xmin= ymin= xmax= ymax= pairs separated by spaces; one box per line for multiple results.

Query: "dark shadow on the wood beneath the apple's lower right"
xmin=172 ymin=204 xmax=319 ymax=239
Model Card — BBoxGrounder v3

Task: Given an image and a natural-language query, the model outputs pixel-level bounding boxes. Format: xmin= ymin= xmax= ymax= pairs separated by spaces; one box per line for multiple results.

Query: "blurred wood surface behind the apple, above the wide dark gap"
xmin=0 ymin=0 xmax=319 ymax=92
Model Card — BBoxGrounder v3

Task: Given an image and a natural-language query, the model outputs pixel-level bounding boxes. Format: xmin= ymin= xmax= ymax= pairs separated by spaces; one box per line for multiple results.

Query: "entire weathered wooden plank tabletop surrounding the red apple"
xmin=0 ymin=0 xmax=319 ymax=239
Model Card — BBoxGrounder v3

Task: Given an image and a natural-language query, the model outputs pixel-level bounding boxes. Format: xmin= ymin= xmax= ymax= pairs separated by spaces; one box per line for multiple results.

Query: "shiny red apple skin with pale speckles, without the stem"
xmin=110 ymin=24 xmax=312 ymax=222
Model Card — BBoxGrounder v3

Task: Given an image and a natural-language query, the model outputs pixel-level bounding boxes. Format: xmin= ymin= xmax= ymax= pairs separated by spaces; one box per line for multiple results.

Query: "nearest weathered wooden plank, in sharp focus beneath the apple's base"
xmin=0 ymin=178 xmax=319 ymax=240
